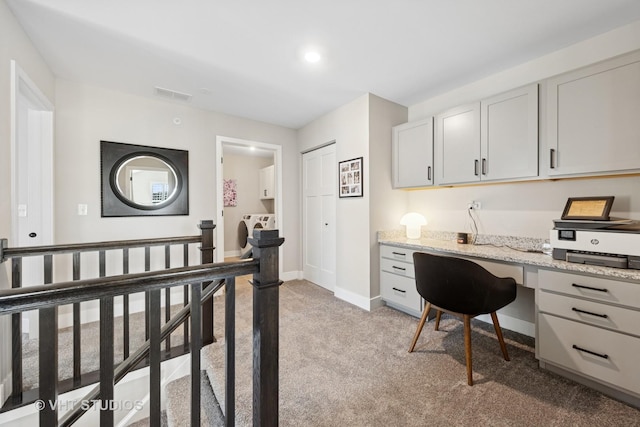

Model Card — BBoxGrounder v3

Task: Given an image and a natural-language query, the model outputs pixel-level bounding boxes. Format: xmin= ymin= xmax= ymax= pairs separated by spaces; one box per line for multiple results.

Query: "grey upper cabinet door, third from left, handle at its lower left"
xmin=480 ymin=84 xmax=538 ymax=181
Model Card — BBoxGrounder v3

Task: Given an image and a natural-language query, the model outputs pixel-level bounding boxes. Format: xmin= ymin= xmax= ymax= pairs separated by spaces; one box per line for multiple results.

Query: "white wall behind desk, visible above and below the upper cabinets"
xmin=406 ymin=21 xmax=640 ymax=238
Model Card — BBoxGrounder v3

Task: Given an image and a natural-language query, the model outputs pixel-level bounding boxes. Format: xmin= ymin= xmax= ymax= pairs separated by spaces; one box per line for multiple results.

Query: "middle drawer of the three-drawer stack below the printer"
xmin=538 ymin=290 xmax=640 ymax=335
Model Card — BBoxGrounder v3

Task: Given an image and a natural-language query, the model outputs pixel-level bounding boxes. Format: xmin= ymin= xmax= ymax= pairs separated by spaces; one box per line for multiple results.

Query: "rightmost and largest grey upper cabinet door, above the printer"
xmin=546 ymin=53 xmax=640 ymax=175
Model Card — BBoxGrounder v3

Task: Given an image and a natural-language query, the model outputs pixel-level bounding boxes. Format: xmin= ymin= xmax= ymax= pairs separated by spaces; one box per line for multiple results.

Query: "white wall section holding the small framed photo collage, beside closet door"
xmin=298 ymin=94 xmax=371 ymax=307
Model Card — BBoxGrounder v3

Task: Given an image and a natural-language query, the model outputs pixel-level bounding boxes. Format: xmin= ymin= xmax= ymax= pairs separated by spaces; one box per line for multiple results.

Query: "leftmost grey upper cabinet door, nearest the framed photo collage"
xmin=391 ymin=117 xmax=433 ymax=188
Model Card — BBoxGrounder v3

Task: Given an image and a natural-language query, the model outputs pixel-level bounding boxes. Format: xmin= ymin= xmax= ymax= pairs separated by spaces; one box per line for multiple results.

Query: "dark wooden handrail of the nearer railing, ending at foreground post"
xmin=0 ymin=259 xmax=259 ymax=314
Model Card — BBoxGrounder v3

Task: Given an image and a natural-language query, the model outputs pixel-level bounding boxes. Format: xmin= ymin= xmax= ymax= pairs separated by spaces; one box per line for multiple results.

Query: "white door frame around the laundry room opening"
xmin=215 ymin=135 xmax=284 ymax=270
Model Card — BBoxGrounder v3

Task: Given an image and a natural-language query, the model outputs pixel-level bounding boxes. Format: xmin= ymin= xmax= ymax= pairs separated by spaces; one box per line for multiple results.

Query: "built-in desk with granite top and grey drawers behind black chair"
xmin=378 ymin=231 xmax=640 ymax=407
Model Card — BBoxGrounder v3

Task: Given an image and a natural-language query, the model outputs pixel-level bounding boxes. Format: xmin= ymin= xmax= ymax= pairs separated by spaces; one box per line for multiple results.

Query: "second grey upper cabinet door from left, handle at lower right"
xmin=434 ymin=102 xmax=480 ymax=184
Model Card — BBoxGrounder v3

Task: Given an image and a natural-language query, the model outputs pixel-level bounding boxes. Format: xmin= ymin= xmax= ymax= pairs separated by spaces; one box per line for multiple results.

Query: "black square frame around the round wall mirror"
xmin=100 ymin=141 xmax=189 ymax=217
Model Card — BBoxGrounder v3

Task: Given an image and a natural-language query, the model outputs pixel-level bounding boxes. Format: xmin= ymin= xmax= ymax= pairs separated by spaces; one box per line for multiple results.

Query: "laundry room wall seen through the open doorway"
xmin=224 ymin=151 xmax=273 ymax=256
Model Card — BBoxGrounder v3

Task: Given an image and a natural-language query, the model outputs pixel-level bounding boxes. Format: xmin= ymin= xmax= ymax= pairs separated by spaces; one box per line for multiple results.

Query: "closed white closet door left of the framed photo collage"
xmin=302 ymin=144 xmax=337 ymax=291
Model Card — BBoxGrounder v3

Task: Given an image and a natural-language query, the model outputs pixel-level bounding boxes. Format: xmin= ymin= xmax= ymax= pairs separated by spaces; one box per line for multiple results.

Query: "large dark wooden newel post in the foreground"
xmin=249 ymin=230 xmax=284 ymax=427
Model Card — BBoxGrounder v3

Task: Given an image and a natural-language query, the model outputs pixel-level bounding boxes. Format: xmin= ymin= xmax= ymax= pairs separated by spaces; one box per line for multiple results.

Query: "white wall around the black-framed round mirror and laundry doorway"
xmin=55 ymin=80 xmax=299 ymax=271
